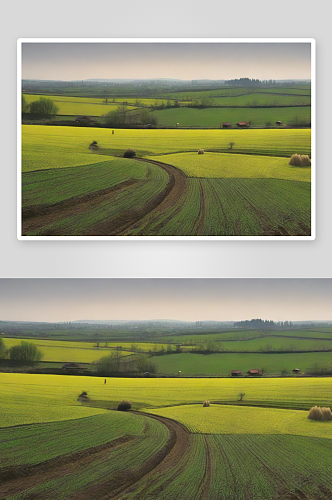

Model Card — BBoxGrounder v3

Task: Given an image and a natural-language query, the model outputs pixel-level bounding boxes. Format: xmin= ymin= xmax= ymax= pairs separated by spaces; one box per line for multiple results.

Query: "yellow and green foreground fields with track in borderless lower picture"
xmin=0 ymin=374 xmax=332 ymax=500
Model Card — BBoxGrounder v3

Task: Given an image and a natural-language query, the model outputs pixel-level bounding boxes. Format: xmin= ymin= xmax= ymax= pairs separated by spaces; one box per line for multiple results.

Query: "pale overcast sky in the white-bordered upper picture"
xmin=22 ymin=42 xmax=311 ymax=80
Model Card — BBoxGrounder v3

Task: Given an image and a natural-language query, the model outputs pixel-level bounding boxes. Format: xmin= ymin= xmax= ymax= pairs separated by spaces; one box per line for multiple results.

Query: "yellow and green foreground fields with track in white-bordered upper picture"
xmin=22 ymin=125 xmax=311 ymax=236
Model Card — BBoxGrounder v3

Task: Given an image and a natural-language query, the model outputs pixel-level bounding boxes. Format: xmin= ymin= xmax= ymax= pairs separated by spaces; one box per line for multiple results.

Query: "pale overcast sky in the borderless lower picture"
xmin=0 ymin=279 xmax=332 ymax=322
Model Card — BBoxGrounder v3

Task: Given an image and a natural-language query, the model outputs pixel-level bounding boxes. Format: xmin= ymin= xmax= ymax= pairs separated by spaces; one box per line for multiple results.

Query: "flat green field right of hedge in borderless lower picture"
xmin=154 ymin=352 xmax=331 ymax=375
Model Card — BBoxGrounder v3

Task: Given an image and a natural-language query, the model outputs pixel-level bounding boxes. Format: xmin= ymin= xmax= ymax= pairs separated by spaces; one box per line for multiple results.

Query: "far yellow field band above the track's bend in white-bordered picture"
xmin=22 ymin=125 xmax=311 ymax=164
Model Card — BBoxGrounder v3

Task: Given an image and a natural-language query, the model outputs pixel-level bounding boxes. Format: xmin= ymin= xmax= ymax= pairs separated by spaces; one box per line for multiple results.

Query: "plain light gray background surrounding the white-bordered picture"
xmin=0 ymin=0 xmax=332 ymax=277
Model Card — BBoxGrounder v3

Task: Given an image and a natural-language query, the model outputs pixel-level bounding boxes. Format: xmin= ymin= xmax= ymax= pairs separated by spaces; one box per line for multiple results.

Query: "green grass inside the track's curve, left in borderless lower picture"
xmin=0 ymin=412 xmax=169 ymax=500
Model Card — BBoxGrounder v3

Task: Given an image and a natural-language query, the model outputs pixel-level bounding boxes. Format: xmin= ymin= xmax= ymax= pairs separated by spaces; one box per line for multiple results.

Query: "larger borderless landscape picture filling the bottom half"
xmin=0 ymin=278 xmax=332 ymax=500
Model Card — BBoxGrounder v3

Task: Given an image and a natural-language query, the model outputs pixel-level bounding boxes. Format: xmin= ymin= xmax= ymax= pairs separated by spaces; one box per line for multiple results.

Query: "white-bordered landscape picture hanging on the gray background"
xmin=17 ymin=38 xmax=316 ymax=240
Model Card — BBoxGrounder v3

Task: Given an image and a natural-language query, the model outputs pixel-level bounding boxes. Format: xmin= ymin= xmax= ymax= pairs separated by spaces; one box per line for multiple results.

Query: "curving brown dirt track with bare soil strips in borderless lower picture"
xmin=0 ymin=412 xmax=189 ymax=500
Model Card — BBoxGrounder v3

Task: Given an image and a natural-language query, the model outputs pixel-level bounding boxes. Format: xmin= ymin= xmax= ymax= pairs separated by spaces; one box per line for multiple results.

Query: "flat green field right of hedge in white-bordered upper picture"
xmin=152 ymin=107 xmax=311 ymax=127
